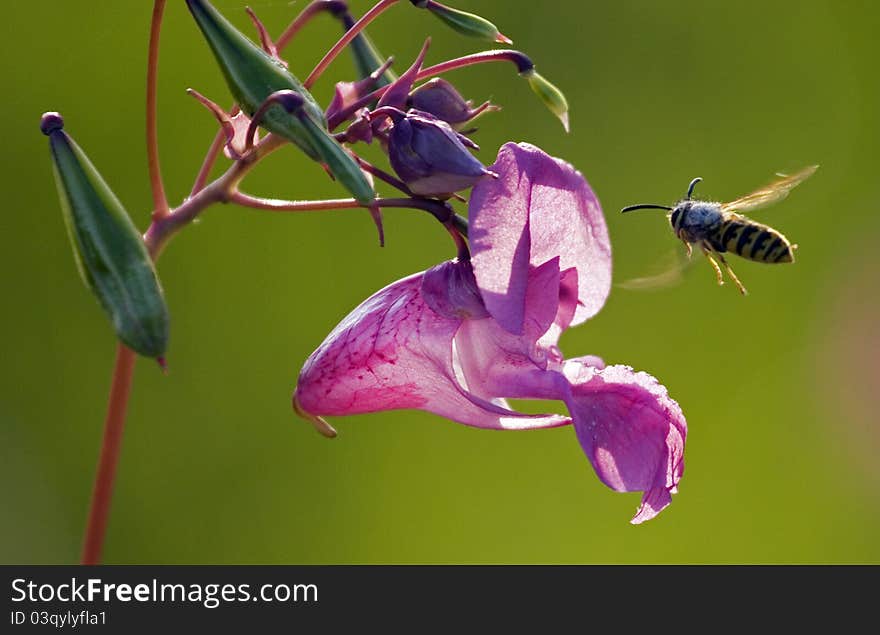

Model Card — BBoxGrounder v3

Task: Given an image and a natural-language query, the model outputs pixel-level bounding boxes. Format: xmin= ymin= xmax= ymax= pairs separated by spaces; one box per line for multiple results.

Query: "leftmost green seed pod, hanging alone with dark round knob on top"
xmin=40 ymin=112 xmax=168 ymax=358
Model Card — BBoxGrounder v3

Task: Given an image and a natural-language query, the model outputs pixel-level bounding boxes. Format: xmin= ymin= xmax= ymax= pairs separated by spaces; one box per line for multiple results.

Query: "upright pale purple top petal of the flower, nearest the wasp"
xmin=469 ymin=143 xmax=611 ymax=334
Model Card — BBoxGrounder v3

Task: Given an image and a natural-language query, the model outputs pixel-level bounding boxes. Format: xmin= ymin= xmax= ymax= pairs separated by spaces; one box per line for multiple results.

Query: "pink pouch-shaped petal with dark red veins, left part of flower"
xmin=294 ymin=274 xmax=570 ymax=429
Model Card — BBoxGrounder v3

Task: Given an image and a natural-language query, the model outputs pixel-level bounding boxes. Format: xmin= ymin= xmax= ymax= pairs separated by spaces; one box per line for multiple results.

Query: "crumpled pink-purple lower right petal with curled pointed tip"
xmin=565 ymin=360 xmax=687 ymax=524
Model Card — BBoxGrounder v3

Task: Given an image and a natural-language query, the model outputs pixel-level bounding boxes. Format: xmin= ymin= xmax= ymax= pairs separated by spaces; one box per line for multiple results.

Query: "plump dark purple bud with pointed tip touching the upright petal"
xmin=384 ymin=108 xmax=494 ymax=198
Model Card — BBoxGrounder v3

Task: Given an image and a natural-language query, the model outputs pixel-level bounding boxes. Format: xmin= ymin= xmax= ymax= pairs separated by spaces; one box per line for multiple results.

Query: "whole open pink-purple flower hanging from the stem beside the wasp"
xmin=294 ymin=143 xmax=687 ymax=523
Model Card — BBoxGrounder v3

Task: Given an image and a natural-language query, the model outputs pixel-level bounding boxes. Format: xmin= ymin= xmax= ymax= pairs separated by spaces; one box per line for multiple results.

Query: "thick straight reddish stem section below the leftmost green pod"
xmin=81 ymin=343 xmax=135 ymax=564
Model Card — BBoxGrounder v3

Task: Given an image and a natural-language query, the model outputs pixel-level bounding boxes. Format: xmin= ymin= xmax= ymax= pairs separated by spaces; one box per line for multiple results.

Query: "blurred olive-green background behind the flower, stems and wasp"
xmin=0 ymin=0 xmax=880 ymax=563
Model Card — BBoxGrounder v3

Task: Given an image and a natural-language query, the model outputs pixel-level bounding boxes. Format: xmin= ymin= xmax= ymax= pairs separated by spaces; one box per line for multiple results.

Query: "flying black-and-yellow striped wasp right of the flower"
xmin=620 ymin=165 xmax=819 ymax=295
